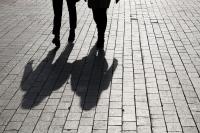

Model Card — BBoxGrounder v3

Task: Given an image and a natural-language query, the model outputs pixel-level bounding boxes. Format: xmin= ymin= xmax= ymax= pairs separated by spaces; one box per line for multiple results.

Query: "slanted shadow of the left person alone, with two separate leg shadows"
xmin=21 ymin=44 xmax=74 ymax=109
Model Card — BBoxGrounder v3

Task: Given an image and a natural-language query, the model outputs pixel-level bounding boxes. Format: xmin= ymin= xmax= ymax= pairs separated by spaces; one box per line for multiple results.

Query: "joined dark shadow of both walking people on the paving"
xmin=21 ymin=44 xmax=118 ymax=110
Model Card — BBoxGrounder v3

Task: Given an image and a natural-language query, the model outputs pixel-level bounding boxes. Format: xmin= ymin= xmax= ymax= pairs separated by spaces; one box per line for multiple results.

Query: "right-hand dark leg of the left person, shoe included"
xmin=67 ymin=0 xmax=77 ymax=42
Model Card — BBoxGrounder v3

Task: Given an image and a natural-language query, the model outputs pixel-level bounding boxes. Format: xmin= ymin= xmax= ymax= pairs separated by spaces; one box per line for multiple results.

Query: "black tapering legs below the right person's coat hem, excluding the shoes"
xmin=92 ymin=8 xmax=107 ymax=41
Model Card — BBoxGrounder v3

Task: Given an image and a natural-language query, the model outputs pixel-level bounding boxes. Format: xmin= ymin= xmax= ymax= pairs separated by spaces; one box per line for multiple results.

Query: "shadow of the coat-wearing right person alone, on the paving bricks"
xmin=71 ymin=47 xmax=118 ymax=110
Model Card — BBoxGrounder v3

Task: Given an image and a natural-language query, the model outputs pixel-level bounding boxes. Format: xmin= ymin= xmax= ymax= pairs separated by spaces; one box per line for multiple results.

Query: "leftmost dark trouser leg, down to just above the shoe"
xmin=53 ymin=0 xmax=63 ymax=36
